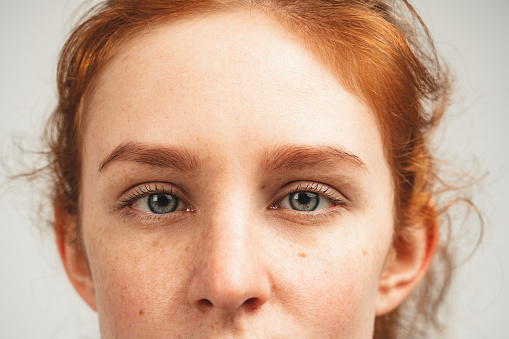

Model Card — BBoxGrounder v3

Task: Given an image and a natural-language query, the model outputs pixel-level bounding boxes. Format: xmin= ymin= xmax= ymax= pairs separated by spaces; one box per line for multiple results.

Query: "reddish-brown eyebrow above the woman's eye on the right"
xmin=262 ymin=145 xmax=368 ymax=172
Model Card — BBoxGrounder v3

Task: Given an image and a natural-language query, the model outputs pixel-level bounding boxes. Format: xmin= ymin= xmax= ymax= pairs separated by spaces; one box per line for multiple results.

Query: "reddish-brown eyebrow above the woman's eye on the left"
xmin=99 ymin=142 xmax=199 ymax=172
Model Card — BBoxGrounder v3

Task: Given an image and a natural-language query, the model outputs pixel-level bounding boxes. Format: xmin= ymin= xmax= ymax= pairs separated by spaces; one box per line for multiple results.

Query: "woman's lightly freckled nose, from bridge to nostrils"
xmin=188 ymin=211 xmax=271 ymax=313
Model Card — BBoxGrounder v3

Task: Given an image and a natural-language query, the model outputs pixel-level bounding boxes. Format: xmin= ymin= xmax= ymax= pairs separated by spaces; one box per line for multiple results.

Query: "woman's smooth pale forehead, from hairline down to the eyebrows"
xmin=85 ymin=10 xmax=383 ymax=177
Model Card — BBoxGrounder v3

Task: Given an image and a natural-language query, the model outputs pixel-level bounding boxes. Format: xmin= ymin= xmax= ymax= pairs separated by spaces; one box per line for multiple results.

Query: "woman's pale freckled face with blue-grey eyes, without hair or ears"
xmin=81 ymin=11 xmax=394 ymax=338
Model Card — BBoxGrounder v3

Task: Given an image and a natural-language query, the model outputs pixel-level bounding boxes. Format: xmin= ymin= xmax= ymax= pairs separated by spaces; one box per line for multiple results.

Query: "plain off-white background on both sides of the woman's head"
xmin=0 ymin=0 xmax=509 ymax=339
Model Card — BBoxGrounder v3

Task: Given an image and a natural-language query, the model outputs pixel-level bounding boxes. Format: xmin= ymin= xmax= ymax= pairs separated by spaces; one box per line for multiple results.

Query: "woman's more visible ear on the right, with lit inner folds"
xmin=376 ymin=203 xmax=438 ymax=316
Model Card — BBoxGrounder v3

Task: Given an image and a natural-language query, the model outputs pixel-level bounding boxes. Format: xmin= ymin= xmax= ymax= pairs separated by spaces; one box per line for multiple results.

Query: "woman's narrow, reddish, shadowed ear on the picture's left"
xmin=55 ymin=207 xmax=97 ymax=311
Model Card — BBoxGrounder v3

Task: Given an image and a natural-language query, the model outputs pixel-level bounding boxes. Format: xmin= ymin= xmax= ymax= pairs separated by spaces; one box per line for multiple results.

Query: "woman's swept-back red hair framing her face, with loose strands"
xmin=47 ymin=0 xmax=450 ymax=338
